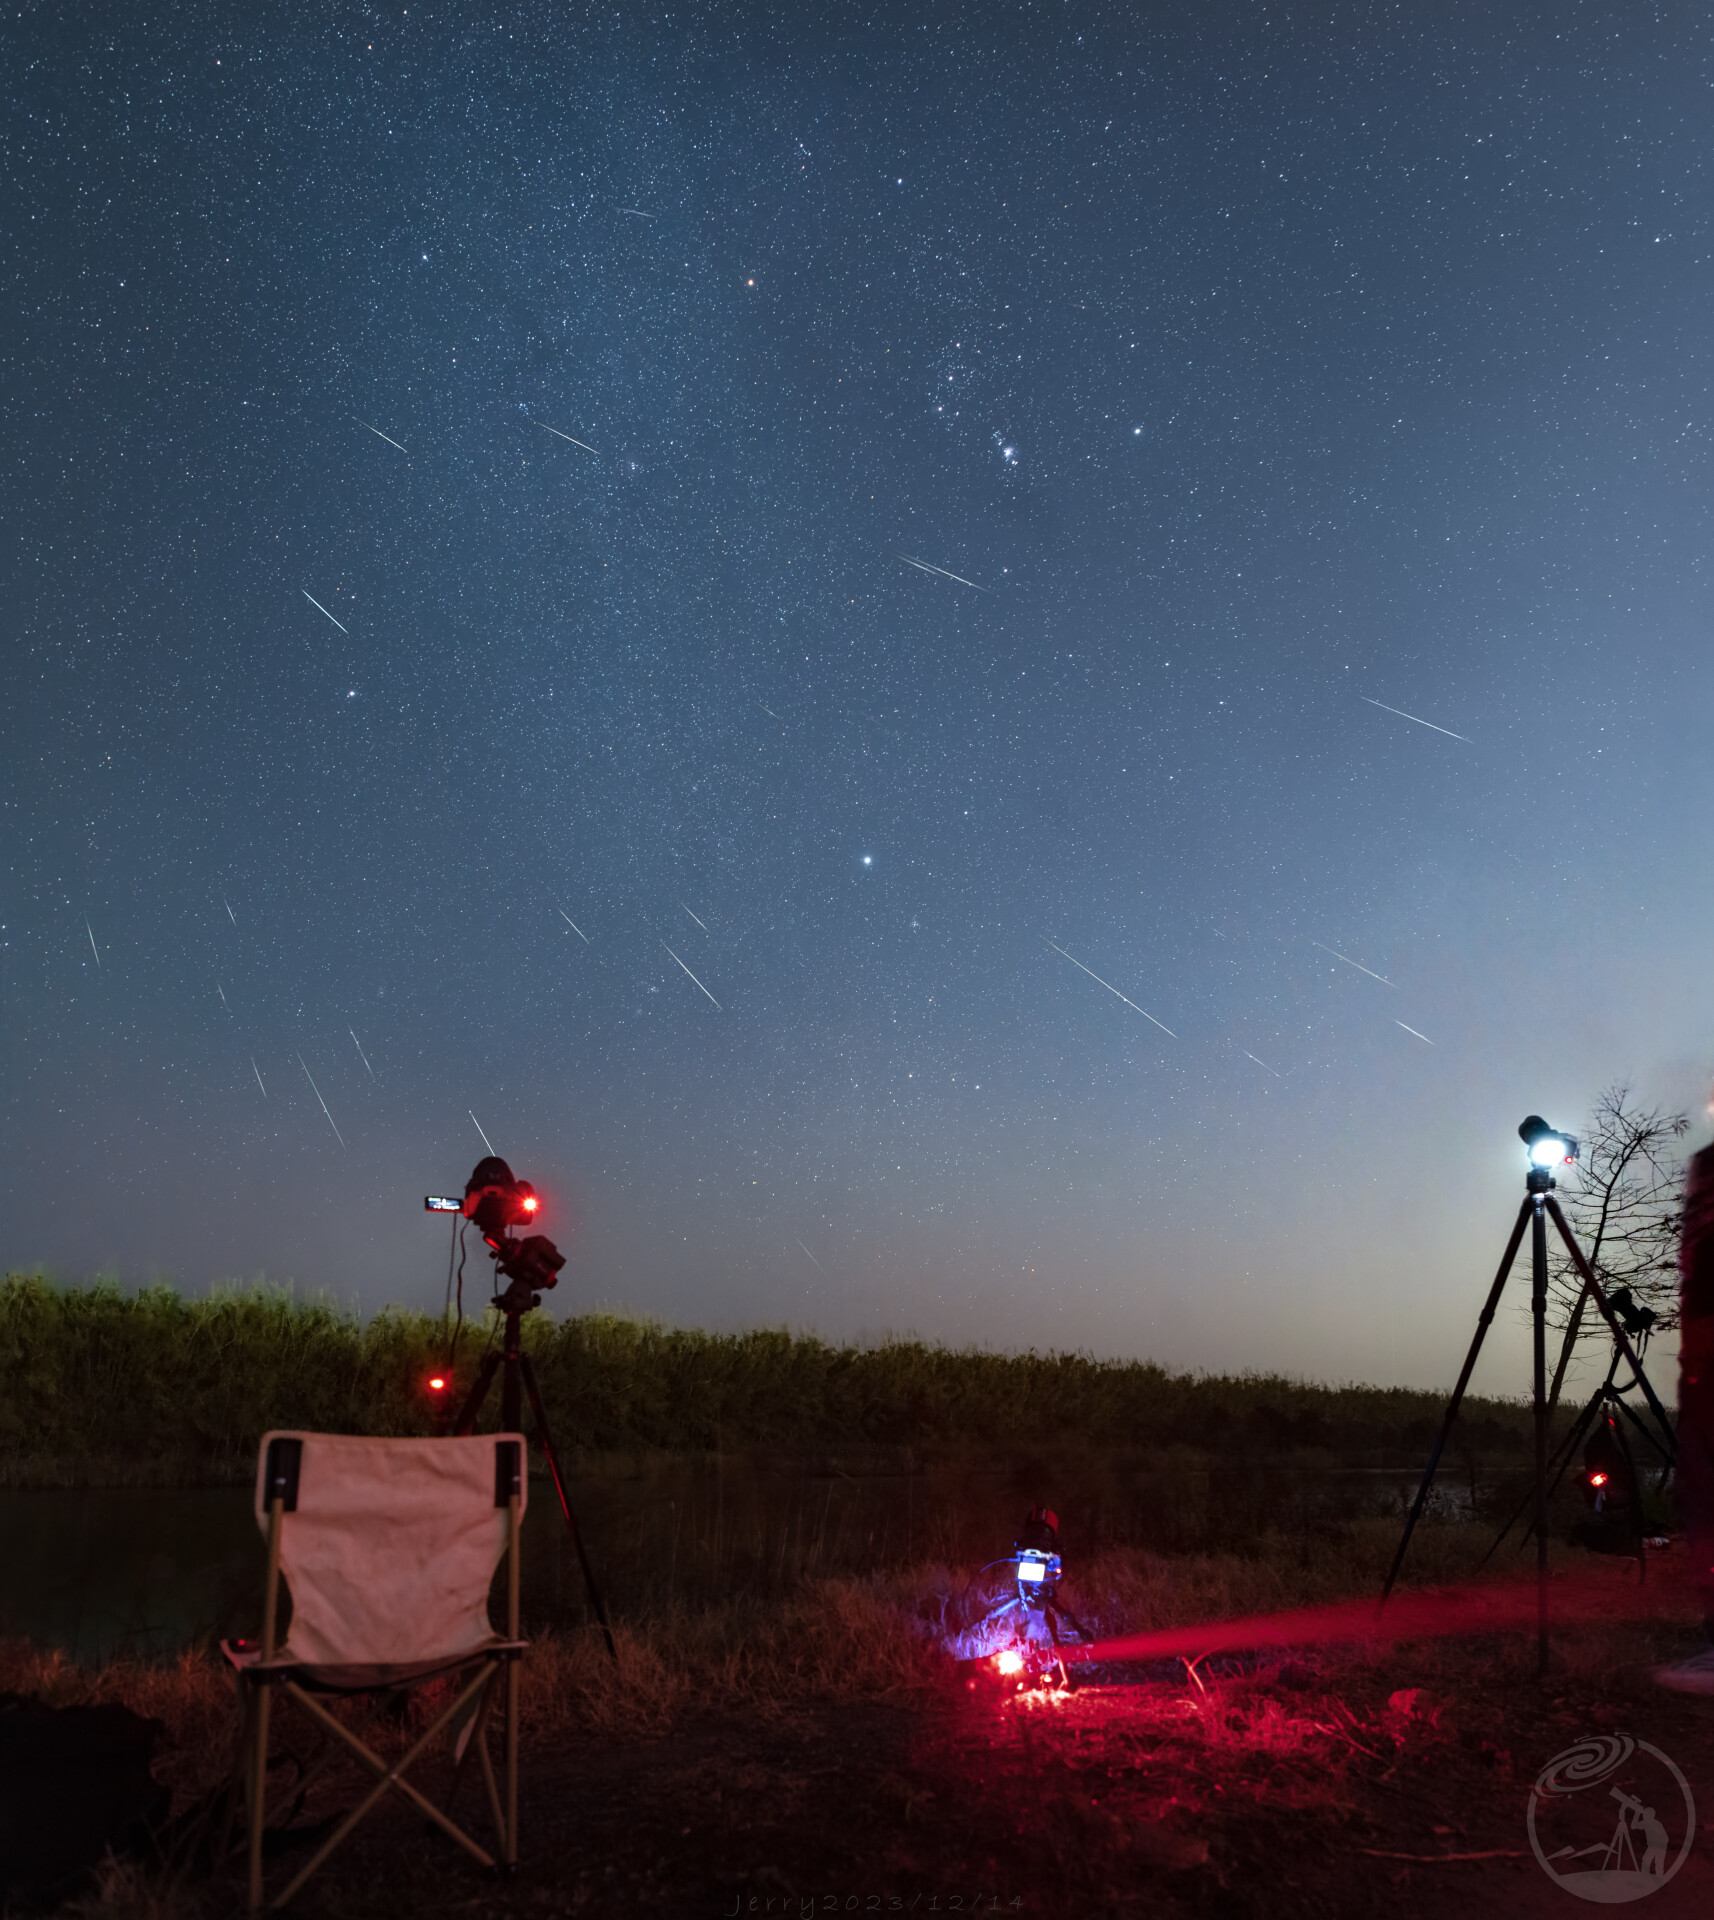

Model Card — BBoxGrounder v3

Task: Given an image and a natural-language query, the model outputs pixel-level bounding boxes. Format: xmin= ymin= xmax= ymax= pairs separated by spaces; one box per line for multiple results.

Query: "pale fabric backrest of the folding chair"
xmin=255 ymin=1432 xmax=528 ymax=1667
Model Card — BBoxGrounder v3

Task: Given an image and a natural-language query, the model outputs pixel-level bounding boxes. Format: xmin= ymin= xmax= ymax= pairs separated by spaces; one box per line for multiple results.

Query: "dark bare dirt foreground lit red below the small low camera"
xmin=81 ymin=1624 xmax=1714 ymax=1920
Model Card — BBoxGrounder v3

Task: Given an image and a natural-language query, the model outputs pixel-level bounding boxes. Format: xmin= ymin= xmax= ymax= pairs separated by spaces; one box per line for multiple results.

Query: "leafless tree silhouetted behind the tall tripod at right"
xmin=1547 ymin=1081 xmax=1691 ymax=1404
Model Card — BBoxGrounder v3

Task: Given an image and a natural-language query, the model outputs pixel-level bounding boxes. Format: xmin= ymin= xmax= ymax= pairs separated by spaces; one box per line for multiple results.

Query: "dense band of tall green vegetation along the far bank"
xmin=0 ymin=1275 xmax=1530 ymax=1484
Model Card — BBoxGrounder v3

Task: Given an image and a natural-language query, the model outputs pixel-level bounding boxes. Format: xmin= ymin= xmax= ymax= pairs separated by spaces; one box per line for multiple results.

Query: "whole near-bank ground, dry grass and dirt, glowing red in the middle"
xmin=20 ymin=1565 xmax=1714 ymax=1920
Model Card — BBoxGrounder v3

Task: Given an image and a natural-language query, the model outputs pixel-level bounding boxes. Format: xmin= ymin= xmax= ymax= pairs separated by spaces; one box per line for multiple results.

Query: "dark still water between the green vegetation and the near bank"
xmin=0 ymin=1450 xmax=1482 ymax=1661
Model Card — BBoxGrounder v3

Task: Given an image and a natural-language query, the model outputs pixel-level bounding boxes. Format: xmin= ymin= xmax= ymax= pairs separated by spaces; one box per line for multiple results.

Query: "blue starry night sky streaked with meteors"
xmin=0 ymin=0 xmax=1714 ymax=1390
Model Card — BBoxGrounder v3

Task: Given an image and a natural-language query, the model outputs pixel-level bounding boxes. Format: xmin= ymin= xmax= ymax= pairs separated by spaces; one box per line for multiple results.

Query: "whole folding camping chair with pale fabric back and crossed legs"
xmin=221 ymin=1432 xmax=528 ymax=1912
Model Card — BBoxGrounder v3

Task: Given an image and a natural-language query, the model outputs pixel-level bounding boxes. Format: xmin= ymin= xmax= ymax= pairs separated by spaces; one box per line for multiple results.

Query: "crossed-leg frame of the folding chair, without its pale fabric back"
xmin=238 ymin=1438 xmax=524 ymax=1914
